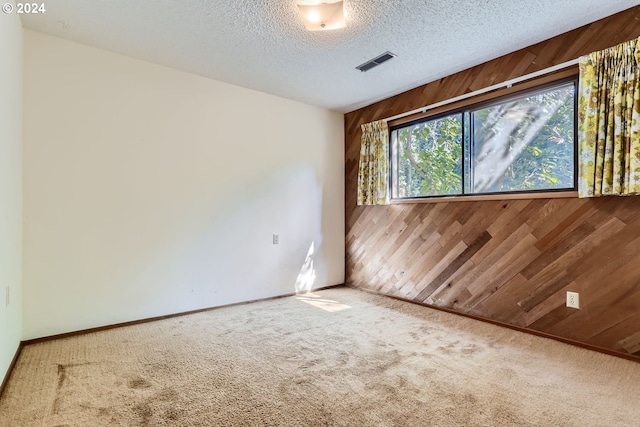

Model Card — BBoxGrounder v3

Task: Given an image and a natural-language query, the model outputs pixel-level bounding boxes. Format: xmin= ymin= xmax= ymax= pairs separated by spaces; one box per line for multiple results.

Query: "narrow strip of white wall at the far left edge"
xmin=0 ymin=1 xmax=22 ymax=382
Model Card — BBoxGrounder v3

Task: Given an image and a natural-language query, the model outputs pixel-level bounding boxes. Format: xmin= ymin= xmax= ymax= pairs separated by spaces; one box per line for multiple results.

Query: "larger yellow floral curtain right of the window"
xmin=578 ymin=38 xmax=640 ymax=197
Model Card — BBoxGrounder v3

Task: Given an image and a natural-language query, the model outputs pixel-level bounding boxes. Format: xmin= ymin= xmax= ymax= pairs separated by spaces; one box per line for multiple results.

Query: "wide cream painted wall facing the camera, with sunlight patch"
xmin=24 ymin=31 xmax=344 ymax=339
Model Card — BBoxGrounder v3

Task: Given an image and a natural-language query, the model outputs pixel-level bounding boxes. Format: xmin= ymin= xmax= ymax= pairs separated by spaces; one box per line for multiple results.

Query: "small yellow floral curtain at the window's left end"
xmin=358 ymin=120 xmax=389 ymax=205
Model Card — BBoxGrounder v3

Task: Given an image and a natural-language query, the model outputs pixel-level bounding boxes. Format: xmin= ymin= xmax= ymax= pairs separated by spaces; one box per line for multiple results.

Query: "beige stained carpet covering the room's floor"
xmin=0 ymin=288 xmax=640 ymax=427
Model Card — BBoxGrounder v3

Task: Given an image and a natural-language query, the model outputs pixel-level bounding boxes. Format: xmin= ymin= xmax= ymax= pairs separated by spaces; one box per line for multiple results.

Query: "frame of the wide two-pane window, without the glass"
xmin=388 ymin=72 xmax=579 ymax=203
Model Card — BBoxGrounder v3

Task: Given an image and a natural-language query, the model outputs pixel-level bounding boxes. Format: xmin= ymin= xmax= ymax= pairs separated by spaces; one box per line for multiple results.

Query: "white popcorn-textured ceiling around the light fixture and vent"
xmin=21 ymin=0 xmax=640 ymax=112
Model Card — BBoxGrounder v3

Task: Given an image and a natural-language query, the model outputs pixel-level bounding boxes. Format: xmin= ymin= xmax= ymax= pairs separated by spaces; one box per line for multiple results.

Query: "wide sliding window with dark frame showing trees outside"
xmin=390 ymin=78 xmax=577 ymax=199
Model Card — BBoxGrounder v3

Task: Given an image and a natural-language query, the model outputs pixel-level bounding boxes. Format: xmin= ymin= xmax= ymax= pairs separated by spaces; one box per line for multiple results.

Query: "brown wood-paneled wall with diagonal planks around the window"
xmin=345 ymin=6 xmax=640 ymax=362
